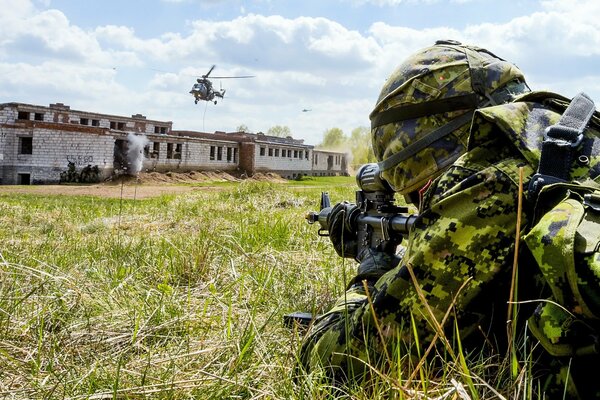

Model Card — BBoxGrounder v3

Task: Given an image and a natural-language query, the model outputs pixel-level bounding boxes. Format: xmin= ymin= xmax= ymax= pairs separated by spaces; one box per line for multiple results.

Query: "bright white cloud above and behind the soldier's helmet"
xmin=369 ymin=0 xmax=600 ymax=89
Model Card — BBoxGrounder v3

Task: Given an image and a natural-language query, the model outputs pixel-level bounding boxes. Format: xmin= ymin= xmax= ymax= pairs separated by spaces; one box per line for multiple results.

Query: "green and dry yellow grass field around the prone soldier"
xmin=0 ymin=178 xmax=540 ymax=399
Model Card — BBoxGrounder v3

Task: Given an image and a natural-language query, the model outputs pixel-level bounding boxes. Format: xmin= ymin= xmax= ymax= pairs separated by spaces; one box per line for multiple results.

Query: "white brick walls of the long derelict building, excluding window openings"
xmin=0 ymin=103 xmax=347 ymax=184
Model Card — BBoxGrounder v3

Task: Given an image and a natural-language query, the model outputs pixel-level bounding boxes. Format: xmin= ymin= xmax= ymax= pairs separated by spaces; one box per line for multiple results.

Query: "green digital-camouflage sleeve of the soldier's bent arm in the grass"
xmin=301 ymin=143 xmax=532 ymax=380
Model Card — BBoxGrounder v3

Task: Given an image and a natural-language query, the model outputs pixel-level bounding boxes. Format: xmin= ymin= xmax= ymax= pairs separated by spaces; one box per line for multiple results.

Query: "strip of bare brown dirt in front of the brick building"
xmin=0 ymin=172 xmax=287 ymax=199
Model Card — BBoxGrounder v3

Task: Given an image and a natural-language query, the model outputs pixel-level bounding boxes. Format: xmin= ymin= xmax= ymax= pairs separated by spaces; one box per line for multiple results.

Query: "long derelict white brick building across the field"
xmin=0 ymin=103 xmax=348 ymax=185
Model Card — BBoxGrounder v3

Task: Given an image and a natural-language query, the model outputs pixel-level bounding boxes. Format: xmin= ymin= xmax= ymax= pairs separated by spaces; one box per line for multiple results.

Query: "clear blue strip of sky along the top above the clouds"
xmin=48 ymin=0 xmax=540 ymax=38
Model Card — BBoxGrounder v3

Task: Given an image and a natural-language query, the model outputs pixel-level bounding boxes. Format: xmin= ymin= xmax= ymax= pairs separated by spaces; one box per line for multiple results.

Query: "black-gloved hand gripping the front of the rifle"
xmin=327 ymin=201 xmax=358 ymax=258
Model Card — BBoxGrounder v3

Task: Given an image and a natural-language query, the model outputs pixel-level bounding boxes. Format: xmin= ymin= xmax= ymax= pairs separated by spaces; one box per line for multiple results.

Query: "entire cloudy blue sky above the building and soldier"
xmin=0 ymin=0 xmax=600 ymax=145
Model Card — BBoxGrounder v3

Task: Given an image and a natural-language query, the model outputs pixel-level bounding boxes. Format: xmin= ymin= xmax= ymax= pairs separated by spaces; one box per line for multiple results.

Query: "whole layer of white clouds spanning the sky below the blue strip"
xmin=0 ymin=0 xmax=600 ymax=147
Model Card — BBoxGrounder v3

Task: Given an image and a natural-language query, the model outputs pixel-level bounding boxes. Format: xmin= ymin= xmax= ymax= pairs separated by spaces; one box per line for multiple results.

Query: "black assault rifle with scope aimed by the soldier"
xmin=284 ymin=164 xmax=417 ymax=326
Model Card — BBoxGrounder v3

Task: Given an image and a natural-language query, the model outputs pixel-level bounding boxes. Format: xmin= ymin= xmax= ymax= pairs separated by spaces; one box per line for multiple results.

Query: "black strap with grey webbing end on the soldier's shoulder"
xmin=528 ymin=93 xmax=595 ymax=197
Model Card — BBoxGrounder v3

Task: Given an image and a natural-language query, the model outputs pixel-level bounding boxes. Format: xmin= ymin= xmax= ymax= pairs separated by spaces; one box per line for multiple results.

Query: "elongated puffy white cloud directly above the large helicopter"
xmin=176 ymin=14 xmax=378 ymax=73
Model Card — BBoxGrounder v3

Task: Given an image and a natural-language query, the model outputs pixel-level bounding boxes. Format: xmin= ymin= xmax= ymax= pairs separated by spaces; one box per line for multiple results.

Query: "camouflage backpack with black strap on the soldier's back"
xmin=524 ymin=93 xmax=600 ymax=357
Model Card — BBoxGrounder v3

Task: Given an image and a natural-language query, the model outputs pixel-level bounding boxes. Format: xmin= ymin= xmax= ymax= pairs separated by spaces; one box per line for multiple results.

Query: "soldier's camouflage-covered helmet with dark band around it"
xmin=370 ymin=40 xmax=529 ymax=195
